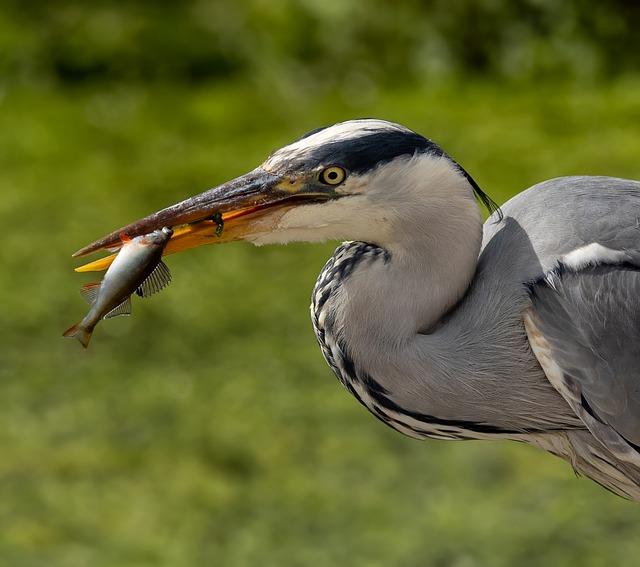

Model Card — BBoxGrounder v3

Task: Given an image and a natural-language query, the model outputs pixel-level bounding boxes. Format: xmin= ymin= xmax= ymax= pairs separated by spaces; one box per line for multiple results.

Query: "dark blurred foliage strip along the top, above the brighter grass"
xmin=0 ymin=0 xmax=640 ymax=90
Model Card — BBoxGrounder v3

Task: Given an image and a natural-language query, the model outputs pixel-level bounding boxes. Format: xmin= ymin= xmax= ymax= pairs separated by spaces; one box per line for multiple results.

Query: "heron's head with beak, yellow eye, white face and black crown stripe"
xmin=76 ymin=119 xmax=496 ymax=262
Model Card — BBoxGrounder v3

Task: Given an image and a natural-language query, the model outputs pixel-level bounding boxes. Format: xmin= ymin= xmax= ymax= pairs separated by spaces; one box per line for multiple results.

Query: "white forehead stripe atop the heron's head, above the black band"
xmin=264 ymin=118 xmax=411 ymax=167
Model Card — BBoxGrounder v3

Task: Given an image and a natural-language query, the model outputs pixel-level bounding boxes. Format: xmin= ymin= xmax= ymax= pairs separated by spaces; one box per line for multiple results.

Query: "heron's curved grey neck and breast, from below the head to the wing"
xmin=312 ymin=164 xmax=577 ymax=439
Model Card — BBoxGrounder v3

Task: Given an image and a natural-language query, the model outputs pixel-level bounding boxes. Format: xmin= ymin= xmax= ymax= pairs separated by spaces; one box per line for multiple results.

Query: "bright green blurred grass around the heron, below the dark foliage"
xmin=0 ymin=79 xmax=640 ymax=567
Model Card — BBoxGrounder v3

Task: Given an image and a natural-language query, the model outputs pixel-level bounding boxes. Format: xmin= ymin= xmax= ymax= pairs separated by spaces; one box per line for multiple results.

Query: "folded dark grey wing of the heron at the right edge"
xmin=524 ymin=261 xmax=640 ymax=465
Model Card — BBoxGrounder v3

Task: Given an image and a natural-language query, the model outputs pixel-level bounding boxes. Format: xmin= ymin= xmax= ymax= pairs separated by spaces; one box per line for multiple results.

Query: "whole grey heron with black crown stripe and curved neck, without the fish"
xmin=76 ymin=119 xmax=640 ymax=500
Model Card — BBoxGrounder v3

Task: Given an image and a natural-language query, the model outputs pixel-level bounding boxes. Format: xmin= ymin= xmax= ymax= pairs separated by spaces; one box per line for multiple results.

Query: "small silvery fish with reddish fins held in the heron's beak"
xmin=62 ymin=227 xmax=173 ymax=349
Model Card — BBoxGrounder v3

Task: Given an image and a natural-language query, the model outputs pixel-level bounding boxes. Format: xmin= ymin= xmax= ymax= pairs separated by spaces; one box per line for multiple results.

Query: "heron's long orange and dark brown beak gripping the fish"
xmin=73 ymin=167 xmax=331 ymax=272
